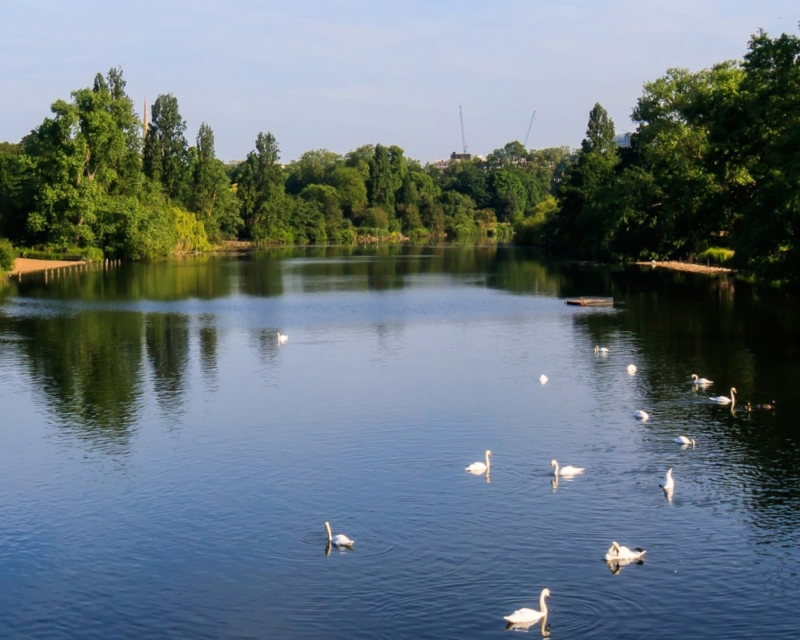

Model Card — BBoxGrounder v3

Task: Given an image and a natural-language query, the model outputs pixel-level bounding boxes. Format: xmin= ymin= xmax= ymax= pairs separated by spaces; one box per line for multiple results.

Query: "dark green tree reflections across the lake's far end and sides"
xmin=0 ymin=245 xmax=800 ymax=530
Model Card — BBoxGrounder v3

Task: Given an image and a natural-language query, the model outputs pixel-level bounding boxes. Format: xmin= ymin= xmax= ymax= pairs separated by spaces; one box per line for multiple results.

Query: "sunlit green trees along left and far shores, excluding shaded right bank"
xmin=0 ymin=68 xmax=570 ymax=259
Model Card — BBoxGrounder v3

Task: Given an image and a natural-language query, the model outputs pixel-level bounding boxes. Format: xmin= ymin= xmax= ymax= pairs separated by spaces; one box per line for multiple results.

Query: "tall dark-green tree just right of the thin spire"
xmin=142 ymin=93 xmax=189 ymax=202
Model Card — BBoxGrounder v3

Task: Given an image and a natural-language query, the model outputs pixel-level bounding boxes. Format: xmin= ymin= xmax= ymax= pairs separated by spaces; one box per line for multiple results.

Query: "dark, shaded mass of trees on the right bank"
xmin=518 ymin=27 xmax=800 ymax=280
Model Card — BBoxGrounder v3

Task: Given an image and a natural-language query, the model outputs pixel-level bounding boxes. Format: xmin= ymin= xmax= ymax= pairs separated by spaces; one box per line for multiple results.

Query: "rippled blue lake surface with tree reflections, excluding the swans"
xmin=0 ymin=248 xmax=800 ymax=640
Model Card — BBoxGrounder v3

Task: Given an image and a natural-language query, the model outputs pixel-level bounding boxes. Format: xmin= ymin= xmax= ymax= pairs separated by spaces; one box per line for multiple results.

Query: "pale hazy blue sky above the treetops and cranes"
xmin=0 ymin=0 xmax=800 ymax=162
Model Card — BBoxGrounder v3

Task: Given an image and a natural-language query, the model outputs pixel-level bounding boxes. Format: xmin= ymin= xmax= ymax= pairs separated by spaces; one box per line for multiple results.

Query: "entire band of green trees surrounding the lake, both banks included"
xmin=0 ymin=27 xmax=800 ymax=280
